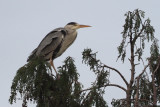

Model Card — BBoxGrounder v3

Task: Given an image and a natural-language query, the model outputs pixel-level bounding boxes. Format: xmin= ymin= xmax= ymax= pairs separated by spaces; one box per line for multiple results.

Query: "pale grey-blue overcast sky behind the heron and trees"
xmin=0 ymin=0 xmax=160 ymax=107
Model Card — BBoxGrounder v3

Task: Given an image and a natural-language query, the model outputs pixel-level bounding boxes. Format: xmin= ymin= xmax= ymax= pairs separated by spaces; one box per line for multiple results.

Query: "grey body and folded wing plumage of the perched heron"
xmin=27 ymin=28 xmax=77 ymax=61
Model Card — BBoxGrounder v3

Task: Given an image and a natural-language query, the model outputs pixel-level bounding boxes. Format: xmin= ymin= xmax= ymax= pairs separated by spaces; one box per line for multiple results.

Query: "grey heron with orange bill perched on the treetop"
xmin=27 ymin=22 xmax=91 ymax=75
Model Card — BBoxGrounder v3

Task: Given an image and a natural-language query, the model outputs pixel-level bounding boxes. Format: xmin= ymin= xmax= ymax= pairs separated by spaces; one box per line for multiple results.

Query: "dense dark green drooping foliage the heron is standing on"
xmin=9 ymin=57 xmax=107 ymax=107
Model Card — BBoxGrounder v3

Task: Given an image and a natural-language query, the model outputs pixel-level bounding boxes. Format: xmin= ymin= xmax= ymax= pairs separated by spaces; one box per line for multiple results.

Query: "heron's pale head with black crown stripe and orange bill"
xmin=65 ymin=22 xmax=91 ymax=30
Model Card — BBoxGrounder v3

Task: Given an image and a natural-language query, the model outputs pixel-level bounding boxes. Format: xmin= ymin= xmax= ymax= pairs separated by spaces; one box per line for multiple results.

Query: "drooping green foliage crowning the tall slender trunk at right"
xmin=118 ymin=9 xmax=155 ymax=62
